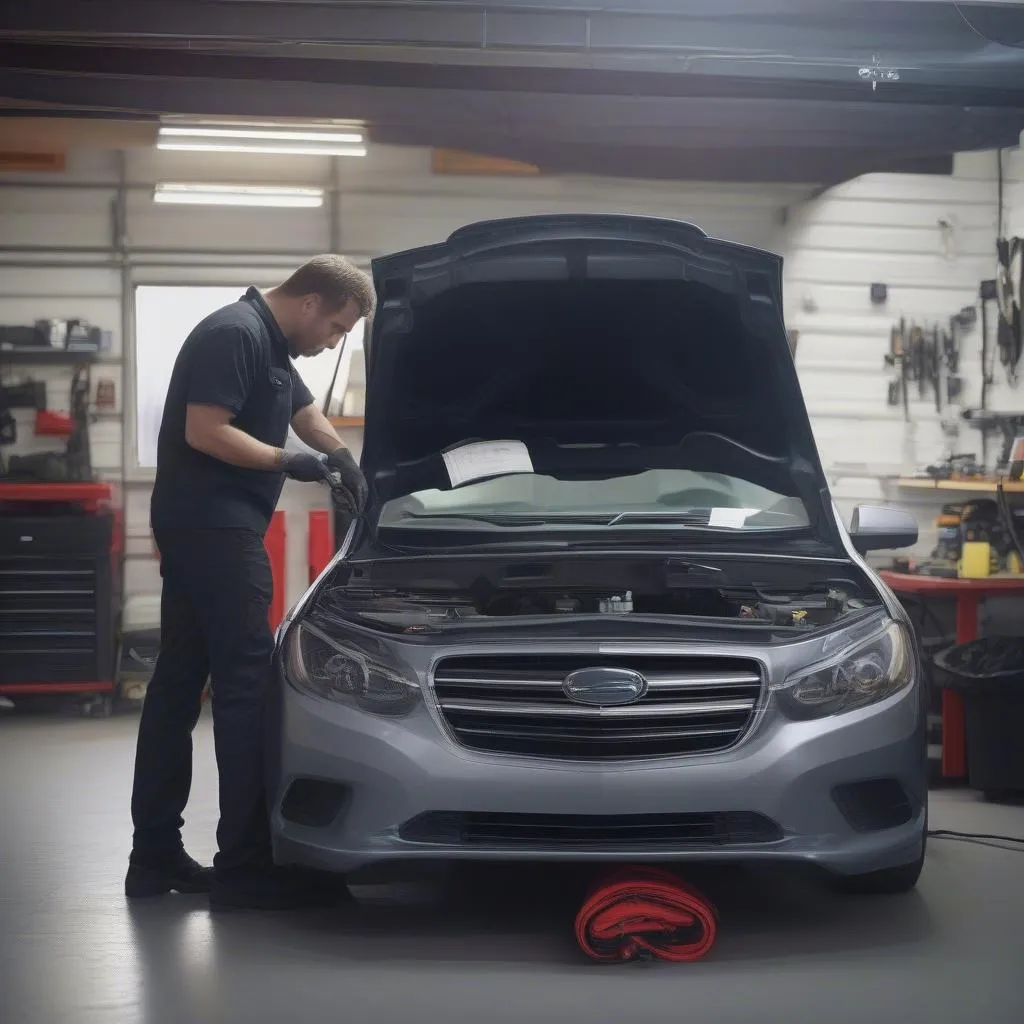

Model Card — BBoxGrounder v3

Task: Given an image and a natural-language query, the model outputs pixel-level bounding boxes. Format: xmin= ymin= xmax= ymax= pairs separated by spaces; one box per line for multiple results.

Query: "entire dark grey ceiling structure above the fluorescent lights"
xmin=0 ymin=0 xmax=1024 ymax=183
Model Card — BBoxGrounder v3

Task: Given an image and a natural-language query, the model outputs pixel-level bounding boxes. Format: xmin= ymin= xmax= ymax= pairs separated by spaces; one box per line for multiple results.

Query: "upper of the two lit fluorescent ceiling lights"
xmin=157 ymin=121 xmax=367 ymax=157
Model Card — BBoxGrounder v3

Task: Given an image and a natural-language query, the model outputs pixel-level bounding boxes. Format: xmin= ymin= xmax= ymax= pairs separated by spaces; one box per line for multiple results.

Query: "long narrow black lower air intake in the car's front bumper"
xmin=400 ymin=811 xmax=782 ymax=850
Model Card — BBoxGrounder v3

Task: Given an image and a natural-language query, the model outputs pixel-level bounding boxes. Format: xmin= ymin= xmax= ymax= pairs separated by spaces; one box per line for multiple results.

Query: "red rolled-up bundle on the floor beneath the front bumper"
xmin=575 ymin=867 xmax=718 ymax=963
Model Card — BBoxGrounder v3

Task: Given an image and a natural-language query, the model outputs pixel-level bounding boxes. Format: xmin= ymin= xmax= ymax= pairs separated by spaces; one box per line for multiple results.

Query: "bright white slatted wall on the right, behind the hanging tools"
xmin=783 ymin=150 xmax=1024 ymax=552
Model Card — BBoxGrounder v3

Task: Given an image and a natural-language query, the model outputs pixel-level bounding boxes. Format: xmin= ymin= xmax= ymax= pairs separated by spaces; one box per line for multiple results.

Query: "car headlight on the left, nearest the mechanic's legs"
xmin=285 ymin=623 xmax=421 ymax=718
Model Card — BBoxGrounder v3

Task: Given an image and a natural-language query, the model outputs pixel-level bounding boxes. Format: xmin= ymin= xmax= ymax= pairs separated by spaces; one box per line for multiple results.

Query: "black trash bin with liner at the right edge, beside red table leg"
xmin=935 ymin=637 xmax=1024 ymax=799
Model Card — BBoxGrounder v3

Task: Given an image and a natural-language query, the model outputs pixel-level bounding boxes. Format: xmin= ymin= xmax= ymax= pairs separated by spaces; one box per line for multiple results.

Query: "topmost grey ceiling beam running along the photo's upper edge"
xmin=0 ymin=0 xmax=1020 ymax=56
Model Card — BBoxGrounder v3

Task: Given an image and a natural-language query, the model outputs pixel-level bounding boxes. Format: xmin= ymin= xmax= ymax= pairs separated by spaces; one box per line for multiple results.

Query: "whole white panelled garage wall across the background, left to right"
xmin=0 ymin=139 xmax=1024 ymax=601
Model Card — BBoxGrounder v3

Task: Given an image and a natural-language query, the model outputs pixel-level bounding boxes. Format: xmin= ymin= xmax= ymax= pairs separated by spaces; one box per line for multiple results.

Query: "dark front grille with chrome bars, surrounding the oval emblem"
xmin=433 ymin=653 xmax=763 ymax=760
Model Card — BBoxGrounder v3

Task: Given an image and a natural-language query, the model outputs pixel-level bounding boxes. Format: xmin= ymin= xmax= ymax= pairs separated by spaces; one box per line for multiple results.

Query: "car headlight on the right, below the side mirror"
xmin=776 ymin=622 xmax=913 ymax=719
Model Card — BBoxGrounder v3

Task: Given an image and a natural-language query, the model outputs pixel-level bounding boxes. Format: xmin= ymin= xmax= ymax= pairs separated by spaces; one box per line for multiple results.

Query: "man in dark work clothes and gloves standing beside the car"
xmin=125 ymin=255 xmax=375 ymax=909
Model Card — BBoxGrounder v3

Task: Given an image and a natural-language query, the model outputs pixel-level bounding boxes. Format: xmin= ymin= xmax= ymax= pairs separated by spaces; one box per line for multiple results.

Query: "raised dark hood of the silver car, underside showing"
xmin=362 ymin=215 xmax=841 ymax=546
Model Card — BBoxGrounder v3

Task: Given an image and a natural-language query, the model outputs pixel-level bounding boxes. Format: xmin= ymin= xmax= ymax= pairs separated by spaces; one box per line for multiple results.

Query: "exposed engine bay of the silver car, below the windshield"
xmin=316 ymin=558 xmax=879 ymax=632
